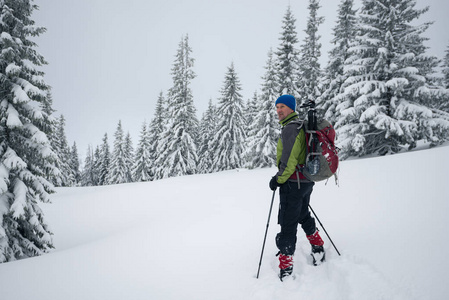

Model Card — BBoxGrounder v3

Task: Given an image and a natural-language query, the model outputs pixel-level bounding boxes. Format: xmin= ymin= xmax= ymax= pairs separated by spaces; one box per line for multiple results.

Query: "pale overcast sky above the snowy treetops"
xmin=32 ymin=0 xmax=449 ymax=157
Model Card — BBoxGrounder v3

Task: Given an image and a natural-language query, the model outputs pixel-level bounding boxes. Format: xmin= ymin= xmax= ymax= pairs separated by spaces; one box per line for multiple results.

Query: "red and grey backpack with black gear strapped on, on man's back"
xmin=296 ymin=101 xmax=339 ymax=184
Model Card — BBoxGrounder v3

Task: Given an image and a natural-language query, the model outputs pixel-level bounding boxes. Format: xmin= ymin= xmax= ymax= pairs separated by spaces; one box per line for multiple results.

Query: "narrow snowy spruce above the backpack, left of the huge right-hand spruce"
xmin=317 ymin=0 xmax=357 ymax=124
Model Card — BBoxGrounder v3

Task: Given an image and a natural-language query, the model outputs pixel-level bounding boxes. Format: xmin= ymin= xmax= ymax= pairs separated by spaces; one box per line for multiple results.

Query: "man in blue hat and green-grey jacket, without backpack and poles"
xmin=270 ymin=95 xmax=325 ymax=281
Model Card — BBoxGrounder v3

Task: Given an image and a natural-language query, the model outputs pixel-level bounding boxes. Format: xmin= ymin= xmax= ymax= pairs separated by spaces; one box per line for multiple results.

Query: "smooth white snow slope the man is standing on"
xmin=0 ymin=147 xmax=449 ymax=300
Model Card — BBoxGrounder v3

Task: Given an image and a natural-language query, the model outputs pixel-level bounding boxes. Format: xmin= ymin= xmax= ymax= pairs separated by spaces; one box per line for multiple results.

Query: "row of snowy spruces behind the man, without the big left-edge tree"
xmin=76 ymin=0 xmax=449 ymax=185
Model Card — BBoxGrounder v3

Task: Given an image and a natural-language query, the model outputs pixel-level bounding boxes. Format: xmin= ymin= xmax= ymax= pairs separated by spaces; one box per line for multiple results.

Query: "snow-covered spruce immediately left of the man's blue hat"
xmin=248 ymin=50 xmax=279 ymax=168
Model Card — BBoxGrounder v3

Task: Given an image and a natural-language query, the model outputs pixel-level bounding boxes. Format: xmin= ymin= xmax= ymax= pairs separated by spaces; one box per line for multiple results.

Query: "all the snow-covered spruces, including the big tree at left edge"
xmin=0 ymin=0 xmax=449 ymax=262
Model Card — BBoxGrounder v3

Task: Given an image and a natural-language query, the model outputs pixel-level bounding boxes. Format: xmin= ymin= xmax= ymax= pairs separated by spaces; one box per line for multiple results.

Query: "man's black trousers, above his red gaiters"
xmin=276 ymin=181 xmax=316 ymax=255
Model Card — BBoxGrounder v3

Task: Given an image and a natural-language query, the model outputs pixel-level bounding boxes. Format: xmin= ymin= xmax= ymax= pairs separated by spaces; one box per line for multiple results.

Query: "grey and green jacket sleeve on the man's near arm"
xmin=277 ymin=124 xmax=305 ymax=184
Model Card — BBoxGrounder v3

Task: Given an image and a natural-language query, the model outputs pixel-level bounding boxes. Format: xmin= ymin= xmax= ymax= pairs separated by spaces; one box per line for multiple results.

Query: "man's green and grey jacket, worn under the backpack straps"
xmin=276 ymin=112 xmax=308 ymax=184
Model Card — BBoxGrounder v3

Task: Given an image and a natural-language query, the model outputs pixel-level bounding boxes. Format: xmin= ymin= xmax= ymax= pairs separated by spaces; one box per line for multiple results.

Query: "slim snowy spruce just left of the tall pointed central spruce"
xmin=148 ymin=92 xmax=167 ymax=180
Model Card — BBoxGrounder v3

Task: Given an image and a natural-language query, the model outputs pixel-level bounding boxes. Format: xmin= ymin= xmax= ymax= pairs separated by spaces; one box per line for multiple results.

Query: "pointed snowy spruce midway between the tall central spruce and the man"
xmin=211 ymin=63 xmax=246 ymax=172
